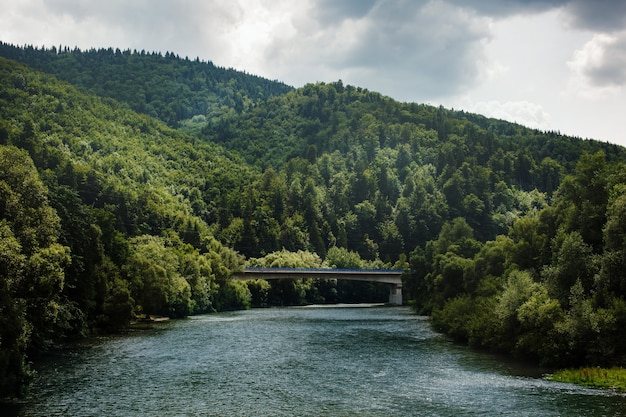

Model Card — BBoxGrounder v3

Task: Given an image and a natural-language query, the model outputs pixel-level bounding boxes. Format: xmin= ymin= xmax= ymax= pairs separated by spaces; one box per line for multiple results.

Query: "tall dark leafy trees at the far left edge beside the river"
xmin=0 ymin=145 xmax=70 ymax=396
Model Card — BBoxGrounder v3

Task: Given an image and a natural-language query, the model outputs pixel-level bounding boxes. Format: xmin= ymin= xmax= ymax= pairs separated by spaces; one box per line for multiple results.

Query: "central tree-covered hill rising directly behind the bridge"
xmin=203 ymin=82 xmax=624 ymax=263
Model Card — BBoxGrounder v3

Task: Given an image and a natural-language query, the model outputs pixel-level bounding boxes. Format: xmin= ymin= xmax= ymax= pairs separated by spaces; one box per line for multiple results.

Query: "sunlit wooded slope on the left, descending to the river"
xmin=0 ymin=59 xmax=254 ymax=393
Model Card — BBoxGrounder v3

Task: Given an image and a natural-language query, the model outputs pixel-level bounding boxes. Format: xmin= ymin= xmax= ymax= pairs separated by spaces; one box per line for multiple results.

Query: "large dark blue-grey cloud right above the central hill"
xmin=346 ymin=3 xmax=489 ymax=95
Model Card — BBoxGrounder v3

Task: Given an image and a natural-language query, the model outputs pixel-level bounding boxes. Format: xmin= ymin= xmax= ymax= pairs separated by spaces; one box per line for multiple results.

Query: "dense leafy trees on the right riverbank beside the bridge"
xmin=408 ymin=153 xmax=626 ymax=366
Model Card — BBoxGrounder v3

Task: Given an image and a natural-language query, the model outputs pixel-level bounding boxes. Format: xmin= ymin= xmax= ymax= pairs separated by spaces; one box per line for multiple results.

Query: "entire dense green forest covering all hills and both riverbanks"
xmin=0 ymin=44 xmax=626 ymax=395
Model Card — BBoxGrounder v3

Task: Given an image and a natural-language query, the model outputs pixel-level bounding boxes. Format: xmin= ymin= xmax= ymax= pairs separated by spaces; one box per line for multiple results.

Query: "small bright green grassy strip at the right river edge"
xmin=547 ymin=368 xmax=626 ymax=392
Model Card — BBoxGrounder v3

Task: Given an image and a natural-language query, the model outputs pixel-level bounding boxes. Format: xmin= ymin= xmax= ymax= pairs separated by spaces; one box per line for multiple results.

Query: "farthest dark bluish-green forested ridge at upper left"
xmin=0 ymin=41 xmax=292 ymax=127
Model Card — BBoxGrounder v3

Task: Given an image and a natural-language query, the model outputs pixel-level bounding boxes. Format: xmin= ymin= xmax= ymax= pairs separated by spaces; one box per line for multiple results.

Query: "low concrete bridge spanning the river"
xmin=233 ymin=268 xmax=404 ymax=305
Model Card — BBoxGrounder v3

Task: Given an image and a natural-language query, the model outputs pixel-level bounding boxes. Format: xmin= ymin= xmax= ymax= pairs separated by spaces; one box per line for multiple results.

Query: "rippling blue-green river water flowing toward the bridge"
xmin=8 ymin=307 xmax=626 ymax=417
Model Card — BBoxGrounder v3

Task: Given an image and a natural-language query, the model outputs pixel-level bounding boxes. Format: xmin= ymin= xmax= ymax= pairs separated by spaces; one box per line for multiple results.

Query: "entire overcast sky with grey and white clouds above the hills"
xmin=0 ymin=0 xmax=626 ymax=146
